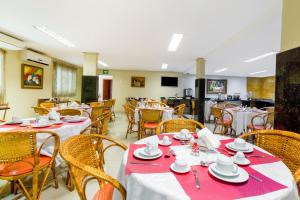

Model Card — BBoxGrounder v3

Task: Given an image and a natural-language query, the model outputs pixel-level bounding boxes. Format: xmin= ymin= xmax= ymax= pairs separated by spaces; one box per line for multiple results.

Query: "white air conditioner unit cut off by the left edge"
xmin=0 ymin=33 xmax=25 ymax=50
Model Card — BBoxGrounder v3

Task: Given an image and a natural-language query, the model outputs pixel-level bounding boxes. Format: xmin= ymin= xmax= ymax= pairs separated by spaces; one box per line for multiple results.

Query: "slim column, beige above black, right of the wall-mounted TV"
xmin=195 ymin=58 xmax=205 ymax=124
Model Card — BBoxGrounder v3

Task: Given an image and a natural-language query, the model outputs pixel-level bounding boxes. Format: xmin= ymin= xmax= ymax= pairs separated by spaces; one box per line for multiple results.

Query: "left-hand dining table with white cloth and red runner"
xmin=0 ymin=117 xmax=91 ymax=165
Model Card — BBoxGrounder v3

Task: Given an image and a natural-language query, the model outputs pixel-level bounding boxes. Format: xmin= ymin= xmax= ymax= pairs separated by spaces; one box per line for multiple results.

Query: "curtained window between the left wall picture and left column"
xmin=53 ymin=62 xmax=77 ymax=97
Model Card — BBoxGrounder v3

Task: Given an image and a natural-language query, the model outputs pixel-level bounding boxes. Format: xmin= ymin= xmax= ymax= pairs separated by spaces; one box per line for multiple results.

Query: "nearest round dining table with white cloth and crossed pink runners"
xmin=113 ymin=133 xmax=299 ymax=200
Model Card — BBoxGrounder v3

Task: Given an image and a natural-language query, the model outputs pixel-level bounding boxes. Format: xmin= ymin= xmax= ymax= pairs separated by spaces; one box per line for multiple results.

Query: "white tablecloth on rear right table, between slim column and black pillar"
xmin=226 ymin=108 xmax=265 ymax=135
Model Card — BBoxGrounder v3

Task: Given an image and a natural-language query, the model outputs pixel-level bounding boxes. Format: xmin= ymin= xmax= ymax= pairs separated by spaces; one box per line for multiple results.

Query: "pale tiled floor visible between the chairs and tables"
xmin=1 ymin=113 xmax=213 ymax=200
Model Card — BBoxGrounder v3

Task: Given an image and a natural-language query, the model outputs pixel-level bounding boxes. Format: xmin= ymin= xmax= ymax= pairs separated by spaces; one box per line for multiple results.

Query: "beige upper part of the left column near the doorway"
xmin=83 ymin=52 xmax=99 ymax=76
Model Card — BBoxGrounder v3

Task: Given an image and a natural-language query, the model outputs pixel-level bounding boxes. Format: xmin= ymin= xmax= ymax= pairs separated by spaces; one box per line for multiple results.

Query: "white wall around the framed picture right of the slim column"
xmin=205 ymin=76 xmax=247 ymax=99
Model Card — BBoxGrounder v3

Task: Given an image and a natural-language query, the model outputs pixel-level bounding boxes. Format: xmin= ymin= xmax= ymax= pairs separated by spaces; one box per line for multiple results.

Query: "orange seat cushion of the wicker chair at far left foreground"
xmin=0 ymin=155 xmax=52 ymax=176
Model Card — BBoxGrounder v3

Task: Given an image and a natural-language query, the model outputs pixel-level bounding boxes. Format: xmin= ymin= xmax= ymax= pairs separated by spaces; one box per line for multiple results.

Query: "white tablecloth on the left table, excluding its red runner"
xmin=0 ymin=118 xmax=91 ymax=165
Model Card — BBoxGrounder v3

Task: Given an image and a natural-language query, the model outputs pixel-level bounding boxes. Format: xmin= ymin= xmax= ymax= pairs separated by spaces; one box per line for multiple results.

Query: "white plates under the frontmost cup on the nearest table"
xmin=208 ymin=163 xmax=249 ymax=183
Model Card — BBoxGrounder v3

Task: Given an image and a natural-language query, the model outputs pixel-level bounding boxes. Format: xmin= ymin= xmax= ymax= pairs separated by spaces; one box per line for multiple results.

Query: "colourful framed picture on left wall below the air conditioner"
xmin=21 ymin=64 xmax=44 ymax=89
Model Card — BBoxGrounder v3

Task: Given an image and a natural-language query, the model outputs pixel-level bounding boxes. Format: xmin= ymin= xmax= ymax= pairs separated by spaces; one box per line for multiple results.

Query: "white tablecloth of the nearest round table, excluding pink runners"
xmin=114 ymin=136 xmax=299 ymax=200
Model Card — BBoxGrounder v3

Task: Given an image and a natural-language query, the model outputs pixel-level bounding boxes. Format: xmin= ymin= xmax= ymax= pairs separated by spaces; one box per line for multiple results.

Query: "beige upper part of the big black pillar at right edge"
xmin=281 ymin=0 xmax=300 ymax=51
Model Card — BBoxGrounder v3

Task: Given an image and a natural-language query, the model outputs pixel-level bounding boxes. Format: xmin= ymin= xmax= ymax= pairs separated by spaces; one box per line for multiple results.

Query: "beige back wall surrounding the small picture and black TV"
xmin=109 ymin=70 xmax=182 ymax=111
